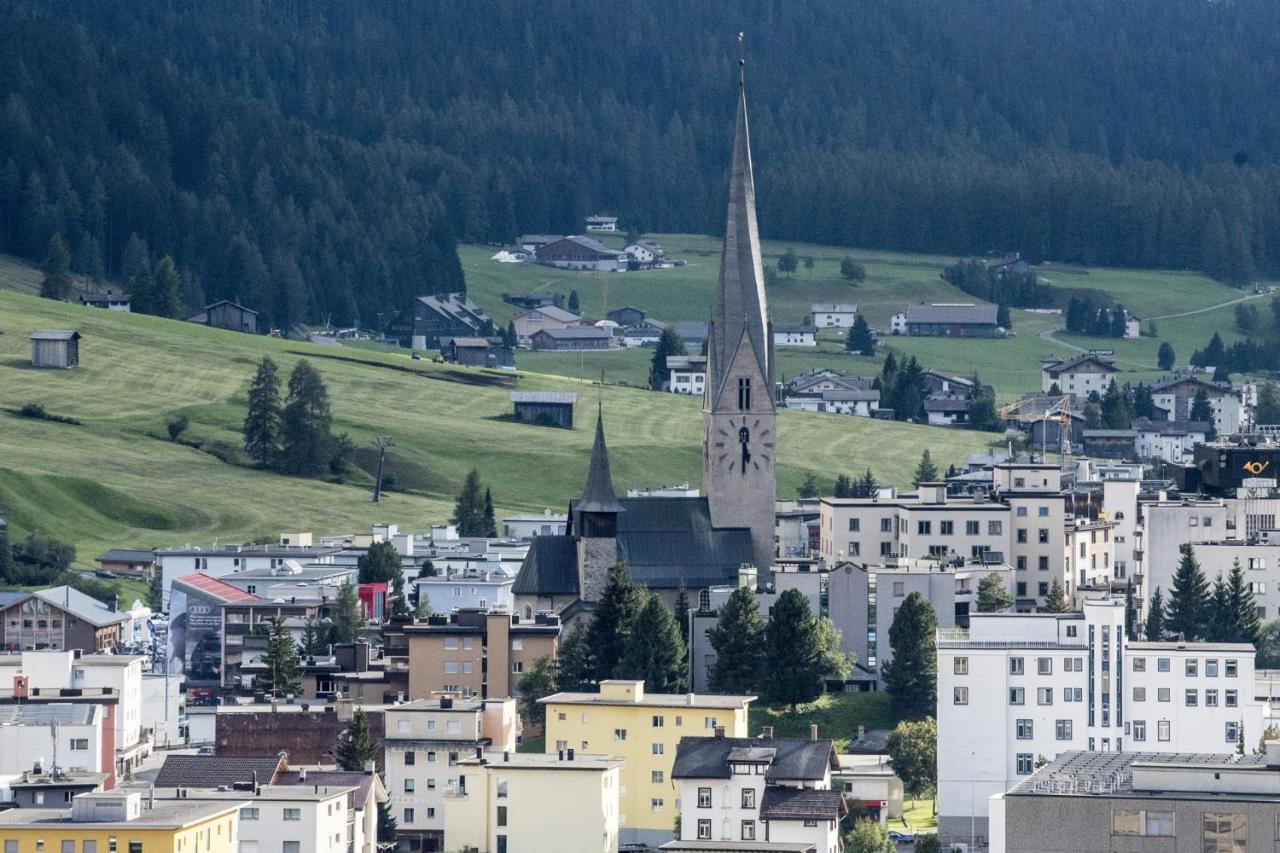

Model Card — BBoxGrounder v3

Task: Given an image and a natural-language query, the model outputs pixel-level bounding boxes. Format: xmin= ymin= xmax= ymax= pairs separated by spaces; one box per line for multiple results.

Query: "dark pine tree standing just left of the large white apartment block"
xmin=883 ymin=592 xmax=938 ymax=720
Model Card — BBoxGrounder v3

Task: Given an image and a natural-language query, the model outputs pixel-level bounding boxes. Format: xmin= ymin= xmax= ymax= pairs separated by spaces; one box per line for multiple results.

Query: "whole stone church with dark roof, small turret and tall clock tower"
xmin=513 ymin=66 xmax=777 ymax=612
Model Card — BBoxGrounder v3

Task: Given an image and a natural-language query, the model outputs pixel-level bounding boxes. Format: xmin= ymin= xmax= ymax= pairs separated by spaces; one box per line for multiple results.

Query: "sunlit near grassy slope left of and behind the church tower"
xmin=0 ymin=291 xmax=989 ymax=565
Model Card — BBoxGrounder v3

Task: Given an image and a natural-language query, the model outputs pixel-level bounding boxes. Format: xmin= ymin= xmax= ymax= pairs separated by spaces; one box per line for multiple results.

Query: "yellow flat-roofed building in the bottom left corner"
xmin=0 ymin=790 xmax=243 ymax=853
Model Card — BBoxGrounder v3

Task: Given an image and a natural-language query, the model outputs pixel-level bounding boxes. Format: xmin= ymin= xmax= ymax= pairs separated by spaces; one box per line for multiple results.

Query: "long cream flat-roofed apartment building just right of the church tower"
xmin=819 ymin=462 xmax=1075 ymax=610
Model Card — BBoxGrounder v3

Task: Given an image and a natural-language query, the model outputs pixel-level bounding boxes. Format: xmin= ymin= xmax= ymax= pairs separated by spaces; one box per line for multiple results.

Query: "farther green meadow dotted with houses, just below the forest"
xmin=460 ymin=234 xmax=1268 ymax=398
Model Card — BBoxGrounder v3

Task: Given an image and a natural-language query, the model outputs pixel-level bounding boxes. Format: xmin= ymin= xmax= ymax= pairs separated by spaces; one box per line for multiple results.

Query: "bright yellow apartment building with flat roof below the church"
xmin=539 ymin=679 xmax=755 ymax=844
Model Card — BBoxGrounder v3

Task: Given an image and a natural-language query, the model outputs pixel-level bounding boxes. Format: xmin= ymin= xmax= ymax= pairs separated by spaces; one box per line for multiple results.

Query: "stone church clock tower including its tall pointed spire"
xmin=703 ymin=64 xmax=777 ymax=576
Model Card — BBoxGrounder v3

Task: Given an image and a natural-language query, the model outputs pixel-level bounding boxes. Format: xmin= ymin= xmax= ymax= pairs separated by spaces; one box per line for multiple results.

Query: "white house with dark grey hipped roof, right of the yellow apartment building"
xmin=660 ymin=729 xmax=846 ymax=853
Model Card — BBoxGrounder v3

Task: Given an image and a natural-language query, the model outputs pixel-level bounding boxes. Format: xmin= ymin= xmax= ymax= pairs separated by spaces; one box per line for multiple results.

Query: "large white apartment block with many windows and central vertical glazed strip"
xmin=937 ymin=599 xmax=1263 ymax=839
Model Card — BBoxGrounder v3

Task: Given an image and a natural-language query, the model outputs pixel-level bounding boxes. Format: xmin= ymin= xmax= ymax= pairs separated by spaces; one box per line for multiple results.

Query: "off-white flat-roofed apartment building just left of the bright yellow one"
xmin=383 ymin=697 xmax=516 ymax=850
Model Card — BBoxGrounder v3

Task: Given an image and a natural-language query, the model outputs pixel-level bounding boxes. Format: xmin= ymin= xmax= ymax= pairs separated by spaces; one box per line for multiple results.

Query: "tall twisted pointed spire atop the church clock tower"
xmin=708 ymin=59 xmax=773 ymax=397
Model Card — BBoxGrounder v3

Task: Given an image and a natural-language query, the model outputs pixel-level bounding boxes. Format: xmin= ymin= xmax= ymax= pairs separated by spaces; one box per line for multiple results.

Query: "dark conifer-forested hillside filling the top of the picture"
xmin=0 ymin=0 xmax=1280 ymax=325
